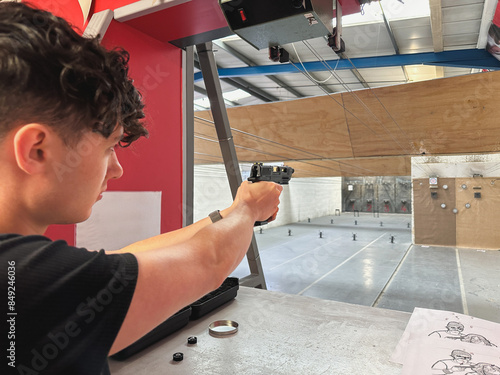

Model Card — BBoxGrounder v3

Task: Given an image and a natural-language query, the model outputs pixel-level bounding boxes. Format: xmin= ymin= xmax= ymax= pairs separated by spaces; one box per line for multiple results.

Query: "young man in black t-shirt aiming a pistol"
xmin=0 ymin=2 xmax=282 ymax=375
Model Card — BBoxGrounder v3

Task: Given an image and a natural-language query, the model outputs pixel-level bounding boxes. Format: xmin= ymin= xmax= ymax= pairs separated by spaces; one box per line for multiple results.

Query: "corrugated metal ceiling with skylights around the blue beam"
xmin=191 ymin=0 xmax=496 ymax=109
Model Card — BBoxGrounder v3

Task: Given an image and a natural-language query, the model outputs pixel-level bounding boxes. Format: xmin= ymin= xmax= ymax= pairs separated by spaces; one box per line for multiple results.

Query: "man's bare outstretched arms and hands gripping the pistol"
xmin=110 ymin=182 xmax=283 ymax=354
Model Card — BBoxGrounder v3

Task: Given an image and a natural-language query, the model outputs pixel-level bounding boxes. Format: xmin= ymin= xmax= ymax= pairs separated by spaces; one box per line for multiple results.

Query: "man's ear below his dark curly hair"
xmin=14 ymin=124 xmax=52 ymax=174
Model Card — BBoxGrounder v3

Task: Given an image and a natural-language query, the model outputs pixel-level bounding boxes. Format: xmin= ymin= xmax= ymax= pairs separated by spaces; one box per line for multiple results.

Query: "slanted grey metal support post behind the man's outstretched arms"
xmin=196 ymin=42 xmax=267 ymax=289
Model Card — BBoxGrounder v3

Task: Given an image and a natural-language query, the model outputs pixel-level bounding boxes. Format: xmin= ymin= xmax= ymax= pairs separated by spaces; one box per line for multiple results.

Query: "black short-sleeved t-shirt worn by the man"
xmin=0 ymin=234 xmax=138 ymax=375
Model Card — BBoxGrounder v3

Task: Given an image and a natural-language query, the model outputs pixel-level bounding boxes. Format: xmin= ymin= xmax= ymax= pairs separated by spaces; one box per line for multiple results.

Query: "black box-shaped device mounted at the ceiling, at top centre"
xmin=219 ymin=0 xmax=334 ymax=50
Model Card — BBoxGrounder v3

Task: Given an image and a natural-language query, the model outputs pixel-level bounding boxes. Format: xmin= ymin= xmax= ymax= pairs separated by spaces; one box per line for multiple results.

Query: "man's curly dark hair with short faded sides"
xmin=0 ymin=2 xmax=148 ymax=146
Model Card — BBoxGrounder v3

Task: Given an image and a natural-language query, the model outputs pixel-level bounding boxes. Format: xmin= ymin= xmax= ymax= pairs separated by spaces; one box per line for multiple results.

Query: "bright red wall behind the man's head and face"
xmin=31 ymin=0 xmax=182 ymax=248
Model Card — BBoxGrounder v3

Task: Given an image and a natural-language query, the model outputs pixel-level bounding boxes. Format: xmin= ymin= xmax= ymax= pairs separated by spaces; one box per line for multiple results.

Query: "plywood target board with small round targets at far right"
xmin=413 ymin=178 xmax=500 ymax=249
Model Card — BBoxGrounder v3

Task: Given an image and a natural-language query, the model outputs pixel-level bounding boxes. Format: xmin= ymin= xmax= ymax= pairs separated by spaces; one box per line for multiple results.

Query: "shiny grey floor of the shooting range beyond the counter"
xmin=232 ymin=213 xmax=500 ymax=323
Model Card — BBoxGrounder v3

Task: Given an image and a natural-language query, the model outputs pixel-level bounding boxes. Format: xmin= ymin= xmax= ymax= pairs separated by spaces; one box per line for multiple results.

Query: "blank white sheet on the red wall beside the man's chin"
xmin=76 ymin=191 xmax=161 ymax=250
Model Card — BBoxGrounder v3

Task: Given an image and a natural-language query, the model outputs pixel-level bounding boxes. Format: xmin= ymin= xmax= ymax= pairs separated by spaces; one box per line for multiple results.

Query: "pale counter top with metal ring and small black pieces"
xmin=109 ymin=287 xmax=411 ymax=375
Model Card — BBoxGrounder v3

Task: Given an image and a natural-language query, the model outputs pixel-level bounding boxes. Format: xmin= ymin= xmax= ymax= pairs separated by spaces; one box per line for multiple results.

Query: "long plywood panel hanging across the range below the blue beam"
xmin=195 ymin=71 xmax=500 ymax=176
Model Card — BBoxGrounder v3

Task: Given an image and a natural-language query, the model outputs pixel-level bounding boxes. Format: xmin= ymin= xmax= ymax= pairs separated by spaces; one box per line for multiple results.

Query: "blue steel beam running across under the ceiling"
xmin=194 ymin=49 xmax=500 ymax=81
